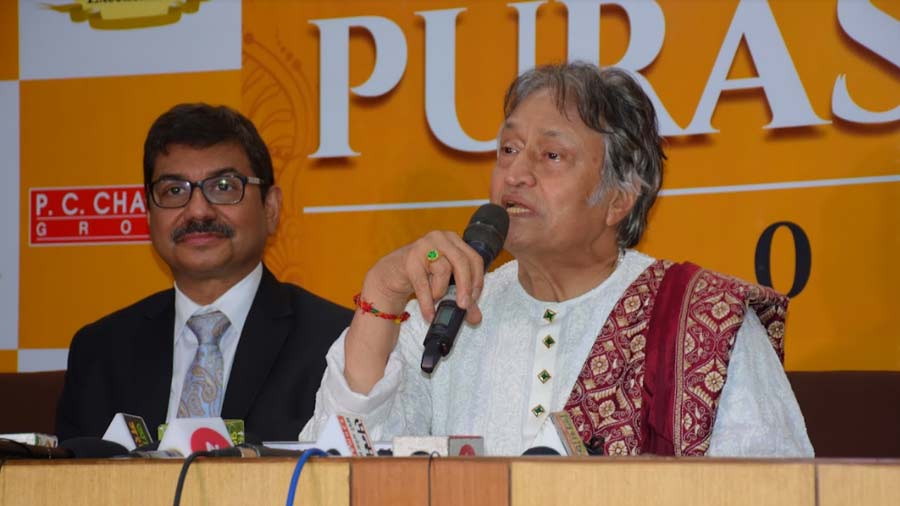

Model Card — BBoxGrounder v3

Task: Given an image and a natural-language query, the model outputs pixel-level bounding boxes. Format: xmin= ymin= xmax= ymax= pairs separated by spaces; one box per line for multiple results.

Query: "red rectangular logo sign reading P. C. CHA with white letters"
xmin=28 ymin=185 xmax=150 ymax=245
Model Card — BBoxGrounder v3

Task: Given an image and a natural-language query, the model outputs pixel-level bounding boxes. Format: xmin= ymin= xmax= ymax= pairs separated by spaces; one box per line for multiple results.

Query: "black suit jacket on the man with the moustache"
xmin=56 ymin=268 xmax=353 ymax=441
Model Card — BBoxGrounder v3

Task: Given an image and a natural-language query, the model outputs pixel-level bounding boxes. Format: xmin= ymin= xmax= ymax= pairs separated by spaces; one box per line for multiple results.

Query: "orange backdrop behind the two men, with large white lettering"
xmin=7 ymin=0 xmax=900 ymax=370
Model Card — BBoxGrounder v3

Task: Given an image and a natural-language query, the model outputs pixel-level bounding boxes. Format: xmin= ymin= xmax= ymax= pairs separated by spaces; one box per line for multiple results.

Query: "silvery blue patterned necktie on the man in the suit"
xmin=178 ymin=311 xmax=231 ymax=418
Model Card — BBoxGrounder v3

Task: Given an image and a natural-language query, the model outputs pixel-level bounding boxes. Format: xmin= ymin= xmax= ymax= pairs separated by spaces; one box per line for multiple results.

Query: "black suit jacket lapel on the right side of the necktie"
xmin=222 ymin=267 xmax=292 ymax=419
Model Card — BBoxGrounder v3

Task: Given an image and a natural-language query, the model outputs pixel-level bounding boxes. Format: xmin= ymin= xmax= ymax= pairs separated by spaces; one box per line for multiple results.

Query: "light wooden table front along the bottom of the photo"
xmin=0 ymin=457 xmax=900 ymax=506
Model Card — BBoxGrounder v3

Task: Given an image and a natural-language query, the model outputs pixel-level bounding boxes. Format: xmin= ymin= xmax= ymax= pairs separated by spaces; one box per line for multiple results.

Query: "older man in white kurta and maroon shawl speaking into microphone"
xmin=301 ymin=63 xmax=812 ymax=456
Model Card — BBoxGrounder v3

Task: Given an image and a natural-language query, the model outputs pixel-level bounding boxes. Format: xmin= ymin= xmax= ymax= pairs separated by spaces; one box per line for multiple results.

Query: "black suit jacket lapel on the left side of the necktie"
xmin=126 ymin=290 xmax=175 ymax=431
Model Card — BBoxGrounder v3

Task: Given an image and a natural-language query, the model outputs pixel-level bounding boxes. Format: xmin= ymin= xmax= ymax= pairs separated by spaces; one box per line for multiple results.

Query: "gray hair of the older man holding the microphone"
xmin=503 ymin=62 xmax=666 ymax=248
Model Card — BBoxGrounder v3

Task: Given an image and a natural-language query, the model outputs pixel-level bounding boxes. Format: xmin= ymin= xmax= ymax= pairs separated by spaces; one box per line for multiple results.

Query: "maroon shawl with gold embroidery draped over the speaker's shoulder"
xmin=565 ymin=260 xmax=788 ymax=455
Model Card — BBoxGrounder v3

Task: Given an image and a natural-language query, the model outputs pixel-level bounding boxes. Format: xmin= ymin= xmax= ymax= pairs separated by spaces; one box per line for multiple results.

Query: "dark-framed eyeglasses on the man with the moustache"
xmin=150 ymin=174 xmax=265 ymax=209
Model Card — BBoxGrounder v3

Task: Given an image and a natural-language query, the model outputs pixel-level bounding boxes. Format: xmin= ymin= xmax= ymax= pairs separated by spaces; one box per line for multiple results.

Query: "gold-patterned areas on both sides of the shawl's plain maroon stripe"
xmin=565 ymin=260 xmax=788 ymax=455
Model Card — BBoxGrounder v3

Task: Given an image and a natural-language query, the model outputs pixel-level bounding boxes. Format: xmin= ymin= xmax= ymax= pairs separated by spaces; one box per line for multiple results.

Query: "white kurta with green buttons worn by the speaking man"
xmin=300 ymin=250 xmax=813 ymax=457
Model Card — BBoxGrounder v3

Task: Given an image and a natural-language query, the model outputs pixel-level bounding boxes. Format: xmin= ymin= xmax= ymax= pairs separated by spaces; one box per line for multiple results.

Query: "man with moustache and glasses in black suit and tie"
xmin=57 ymin=104 xmax=352 ymax=440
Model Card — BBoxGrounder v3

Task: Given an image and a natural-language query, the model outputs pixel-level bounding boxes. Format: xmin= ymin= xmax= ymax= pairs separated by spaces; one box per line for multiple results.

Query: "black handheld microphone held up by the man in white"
xmin=421 ymin=204 xmax=509 ymax=374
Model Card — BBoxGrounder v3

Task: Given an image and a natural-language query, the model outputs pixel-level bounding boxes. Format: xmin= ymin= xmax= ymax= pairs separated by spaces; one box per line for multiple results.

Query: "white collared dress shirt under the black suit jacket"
xmin=166 ymin=263 xmax=262 ymax=423
